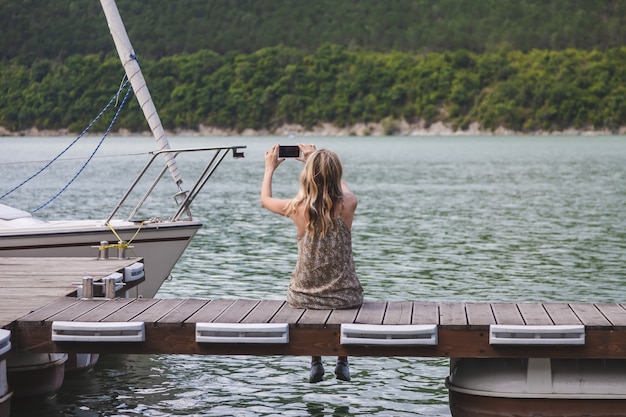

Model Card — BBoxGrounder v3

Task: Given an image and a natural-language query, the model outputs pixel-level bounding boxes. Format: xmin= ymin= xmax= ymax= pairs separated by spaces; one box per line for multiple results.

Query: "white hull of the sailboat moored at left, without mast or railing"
xmin=0 ymin=221 xmax=202 ymax=298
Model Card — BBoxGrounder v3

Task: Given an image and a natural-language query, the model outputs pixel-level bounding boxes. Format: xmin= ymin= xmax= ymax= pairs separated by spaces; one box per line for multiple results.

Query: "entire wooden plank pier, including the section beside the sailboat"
xmin=0 ymin=258 xmax=626 ymax=359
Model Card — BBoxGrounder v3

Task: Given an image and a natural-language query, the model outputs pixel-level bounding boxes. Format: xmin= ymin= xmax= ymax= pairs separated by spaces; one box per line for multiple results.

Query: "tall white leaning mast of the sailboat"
xmin=100 ymin=0 xmax=183 ymax=188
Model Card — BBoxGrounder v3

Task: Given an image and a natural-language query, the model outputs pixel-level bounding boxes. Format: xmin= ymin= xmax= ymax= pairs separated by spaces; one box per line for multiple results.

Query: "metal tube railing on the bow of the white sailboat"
xmin=107 ymin=146 xmax=246 ymax=223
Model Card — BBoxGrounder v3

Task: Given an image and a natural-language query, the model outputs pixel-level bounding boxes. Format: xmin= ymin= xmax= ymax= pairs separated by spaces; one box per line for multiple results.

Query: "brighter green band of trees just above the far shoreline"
xmin=0 ymin=44 xmax=626 ymax=134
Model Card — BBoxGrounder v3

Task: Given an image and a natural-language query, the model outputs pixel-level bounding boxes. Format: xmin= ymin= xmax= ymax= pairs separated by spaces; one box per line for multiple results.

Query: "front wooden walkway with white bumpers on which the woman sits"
xmin=11 ymin=297 xmax=626 ymax=358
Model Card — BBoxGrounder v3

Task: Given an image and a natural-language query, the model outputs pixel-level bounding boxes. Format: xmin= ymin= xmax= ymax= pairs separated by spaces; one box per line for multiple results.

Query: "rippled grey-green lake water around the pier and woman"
xmin=0 ymin=136 xmax=626 ymax=417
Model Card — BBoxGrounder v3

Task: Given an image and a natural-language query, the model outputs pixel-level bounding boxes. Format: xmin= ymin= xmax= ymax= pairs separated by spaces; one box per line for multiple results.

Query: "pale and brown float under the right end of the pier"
xmin=446 ymin=358 xmax=626 ymax=417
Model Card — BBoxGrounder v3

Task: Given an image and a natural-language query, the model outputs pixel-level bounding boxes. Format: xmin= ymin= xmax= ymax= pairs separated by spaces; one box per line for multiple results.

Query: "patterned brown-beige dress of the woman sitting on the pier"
xmin=287 ymin=217 xmax=363 ymax=310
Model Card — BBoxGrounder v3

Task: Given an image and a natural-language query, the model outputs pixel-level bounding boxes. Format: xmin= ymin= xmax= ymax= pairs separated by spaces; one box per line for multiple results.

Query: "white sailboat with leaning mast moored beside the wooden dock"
xmin=0 ymin=0 xmax=245 ymax=297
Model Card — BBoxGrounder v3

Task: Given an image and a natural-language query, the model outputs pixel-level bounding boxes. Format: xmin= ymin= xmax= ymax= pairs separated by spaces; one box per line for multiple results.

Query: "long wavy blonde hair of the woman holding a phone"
xmin=287 ymin=149 xmax=343 ymax=236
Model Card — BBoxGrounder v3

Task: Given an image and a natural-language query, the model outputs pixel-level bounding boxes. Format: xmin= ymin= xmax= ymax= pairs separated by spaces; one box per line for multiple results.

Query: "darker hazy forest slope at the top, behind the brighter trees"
xmin=0 ymin=0 xmax=626 ymax=59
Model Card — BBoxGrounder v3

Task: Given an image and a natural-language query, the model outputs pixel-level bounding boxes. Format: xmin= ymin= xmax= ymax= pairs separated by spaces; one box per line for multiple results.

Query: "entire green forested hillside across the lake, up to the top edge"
xmin=0 ymin=0 xmax=626 ymax=134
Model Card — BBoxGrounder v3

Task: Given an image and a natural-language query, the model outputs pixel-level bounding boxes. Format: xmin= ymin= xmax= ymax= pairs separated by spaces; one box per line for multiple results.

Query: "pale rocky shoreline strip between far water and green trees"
xmin=0 ymin=121 xmax=626 ymax=137
